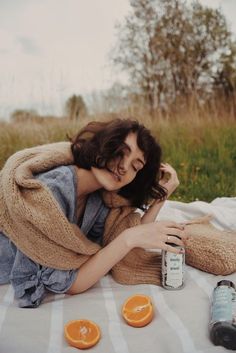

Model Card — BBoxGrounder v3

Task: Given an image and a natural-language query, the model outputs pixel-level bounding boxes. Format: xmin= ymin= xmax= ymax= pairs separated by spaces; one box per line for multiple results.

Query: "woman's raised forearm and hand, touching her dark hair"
xmin=141 ymin=163 xmax=179 ymax=223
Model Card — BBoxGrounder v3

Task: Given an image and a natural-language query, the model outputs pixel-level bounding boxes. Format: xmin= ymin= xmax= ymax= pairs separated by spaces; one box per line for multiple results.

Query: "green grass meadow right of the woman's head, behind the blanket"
xmin=155 ymin=123 xmax=236 ymax=202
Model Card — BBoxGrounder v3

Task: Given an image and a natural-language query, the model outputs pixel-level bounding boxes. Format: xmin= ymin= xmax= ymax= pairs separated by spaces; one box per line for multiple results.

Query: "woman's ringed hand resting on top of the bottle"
xmin=126 ymin=221 xmax=187 ymax=254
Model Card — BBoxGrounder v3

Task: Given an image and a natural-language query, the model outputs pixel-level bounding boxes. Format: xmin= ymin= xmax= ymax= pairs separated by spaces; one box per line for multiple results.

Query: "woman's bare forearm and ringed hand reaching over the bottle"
xmin=67 ymin=222 xmax=186 ymax=294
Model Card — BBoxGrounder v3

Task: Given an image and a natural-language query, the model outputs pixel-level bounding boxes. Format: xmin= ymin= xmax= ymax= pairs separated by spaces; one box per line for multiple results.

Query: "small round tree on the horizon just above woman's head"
xmin=65 ymin=94 xmax=87 ymax=120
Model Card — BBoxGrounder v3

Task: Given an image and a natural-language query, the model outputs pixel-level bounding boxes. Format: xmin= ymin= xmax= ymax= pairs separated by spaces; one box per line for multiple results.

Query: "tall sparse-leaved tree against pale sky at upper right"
xmin=111 ymin=0 xmax=236 ymax=114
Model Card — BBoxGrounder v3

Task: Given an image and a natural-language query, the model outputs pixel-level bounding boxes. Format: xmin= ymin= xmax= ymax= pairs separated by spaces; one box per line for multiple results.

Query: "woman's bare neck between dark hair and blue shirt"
xmin=76 ymin=167 xmax=101 ymax=197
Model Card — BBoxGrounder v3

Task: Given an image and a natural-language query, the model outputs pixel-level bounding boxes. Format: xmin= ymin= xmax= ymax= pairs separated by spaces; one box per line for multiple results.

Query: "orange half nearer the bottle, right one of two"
xmin=122 ymin=294 xmax=154 ymax=327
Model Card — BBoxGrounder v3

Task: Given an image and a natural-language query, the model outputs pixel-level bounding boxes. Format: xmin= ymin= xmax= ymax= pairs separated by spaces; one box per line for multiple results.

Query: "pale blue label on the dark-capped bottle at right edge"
xmin=211 ymin=286 xmax=235 ymax=323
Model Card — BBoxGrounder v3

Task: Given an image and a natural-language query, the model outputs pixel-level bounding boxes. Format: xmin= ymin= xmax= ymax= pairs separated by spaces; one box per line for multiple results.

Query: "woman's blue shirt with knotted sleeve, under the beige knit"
xmin=0 ymin=166 xmax=109 ymax=307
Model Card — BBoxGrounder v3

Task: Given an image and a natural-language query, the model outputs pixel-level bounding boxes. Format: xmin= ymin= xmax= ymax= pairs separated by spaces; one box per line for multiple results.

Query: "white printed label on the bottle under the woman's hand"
xmin=164 ymin=252 xmax=184 ymax=288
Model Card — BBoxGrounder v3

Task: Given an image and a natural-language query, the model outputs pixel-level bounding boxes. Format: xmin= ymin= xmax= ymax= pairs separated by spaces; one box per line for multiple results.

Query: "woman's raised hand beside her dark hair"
xmin=159 ymin=163 xmax=179 ymax=197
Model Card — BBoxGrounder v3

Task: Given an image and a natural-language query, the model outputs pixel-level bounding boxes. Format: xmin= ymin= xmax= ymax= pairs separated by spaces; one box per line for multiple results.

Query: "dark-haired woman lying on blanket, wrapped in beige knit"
xmin=0 ymin=119 xmax=187 ymax=307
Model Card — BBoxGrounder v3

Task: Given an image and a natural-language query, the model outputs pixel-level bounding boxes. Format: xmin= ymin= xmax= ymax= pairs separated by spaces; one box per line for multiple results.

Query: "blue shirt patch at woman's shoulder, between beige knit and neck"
xmin=35 ymin=166 xmax=77 ymax=223
